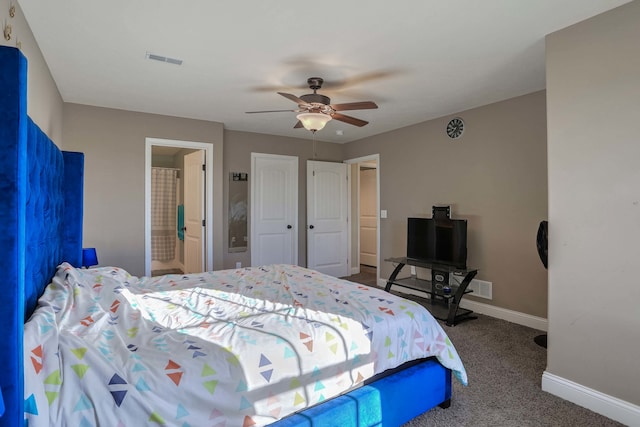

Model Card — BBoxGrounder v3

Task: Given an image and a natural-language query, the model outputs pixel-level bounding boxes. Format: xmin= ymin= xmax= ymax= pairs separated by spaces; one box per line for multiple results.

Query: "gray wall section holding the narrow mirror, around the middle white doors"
xmin=223 ymin=129 xmax=342 ymax=268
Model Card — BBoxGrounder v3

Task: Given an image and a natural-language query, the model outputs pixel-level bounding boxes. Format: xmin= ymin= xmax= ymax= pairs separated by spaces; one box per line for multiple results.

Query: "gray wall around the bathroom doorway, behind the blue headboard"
xmin=63 ymin=103 xmax=223 ymax=275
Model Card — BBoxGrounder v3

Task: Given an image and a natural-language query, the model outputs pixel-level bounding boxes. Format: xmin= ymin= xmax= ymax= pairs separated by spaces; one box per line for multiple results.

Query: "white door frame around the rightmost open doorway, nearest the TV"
xmin=344 ymin=154 xmax=380 ymax=283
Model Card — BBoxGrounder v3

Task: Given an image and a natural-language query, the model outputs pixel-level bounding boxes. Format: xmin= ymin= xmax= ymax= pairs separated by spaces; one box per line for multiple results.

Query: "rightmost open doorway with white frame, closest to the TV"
xmin=346 ymin=154 xmax=380 ymax=285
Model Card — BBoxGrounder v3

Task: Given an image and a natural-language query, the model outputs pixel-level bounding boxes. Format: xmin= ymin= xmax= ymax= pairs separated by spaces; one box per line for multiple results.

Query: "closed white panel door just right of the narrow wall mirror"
xmin=249 ymin=153 xmax=298 ymax=266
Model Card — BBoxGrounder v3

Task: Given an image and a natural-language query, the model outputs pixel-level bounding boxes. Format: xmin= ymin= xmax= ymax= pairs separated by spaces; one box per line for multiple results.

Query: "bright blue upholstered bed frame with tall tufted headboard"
xmin=0 ymin=46 xmax=451 ymax=427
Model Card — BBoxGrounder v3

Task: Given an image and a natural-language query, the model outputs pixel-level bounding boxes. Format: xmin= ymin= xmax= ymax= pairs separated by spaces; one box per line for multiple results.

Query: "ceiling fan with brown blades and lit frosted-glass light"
xmin=247 ymin=77 xmax=378 ymax=132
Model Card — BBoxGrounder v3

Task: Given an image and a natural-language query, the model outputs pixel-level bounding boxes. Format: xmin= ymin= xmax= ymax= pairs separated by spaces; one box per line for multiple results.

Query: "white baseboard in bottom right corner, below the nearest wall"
xmin=542 ymin=371 xmax=640 ymax=427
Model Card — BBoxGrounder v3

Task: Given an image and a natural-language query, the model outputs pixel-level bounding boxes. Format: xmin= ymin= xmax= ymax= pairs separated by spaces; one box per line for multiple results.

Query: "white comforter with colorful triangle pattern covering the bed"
xmin=24 ymin=264 xmax=466 ymax=427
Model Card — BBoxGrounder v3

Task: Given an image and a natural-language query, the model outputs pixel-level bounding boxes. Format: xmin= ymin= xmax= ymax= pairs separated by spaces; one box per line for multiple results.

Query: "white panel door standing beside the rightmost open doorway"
xmin=307 ymin=160 xmax=349 ymax=277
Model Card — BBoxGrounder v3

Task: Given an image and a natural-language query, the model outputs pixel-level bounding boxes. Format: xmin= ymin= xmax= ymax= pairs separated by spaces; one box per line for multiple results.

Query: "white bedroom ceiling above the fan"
xmin=19 ymin=0 xmax=629 ymax=143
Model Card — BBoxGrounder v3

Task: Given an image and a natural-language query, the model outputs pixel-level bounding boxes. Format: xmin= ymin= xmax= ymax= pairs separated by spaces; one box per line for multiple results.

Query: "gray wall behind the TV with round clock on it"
xmin=344 ymin=92 xmax=547 ymax=318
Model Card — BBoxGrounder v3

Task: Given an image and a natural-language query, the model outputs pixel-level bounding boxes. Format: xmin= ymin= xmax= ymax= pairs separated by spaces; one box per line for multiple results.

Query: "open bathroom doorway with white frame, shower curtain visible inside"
xmin=145 ymin=138 xmax=213 ymax=276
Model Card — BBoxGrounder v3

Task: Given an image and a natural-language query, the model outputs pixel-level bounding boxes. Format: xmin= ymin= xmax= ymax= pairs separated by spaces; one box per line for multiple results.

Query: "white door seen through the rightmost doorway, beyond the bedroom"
xmin=360 ymin=167 xmax=378 ymax=267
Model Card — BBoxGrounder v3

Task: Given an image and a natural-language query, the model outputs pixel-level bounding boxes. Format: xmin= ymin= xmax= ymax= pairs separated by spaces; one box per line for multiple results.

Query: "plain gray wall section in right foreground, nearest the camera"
xmin=543 ymin=1 xmax=640 ymax=408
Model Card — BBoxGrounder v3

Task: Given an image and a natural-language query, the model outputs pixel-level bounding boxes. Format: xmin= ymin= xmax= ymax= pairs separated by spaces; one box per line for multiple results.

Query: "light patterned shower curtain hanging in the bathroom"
xmin=151 ymin=167 xmax=178 ymax=261
